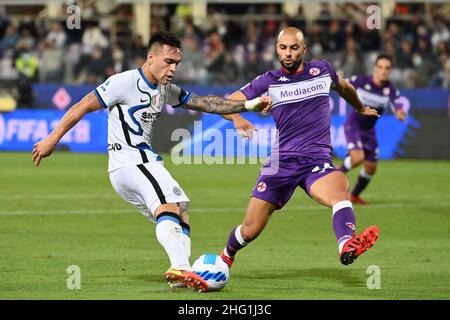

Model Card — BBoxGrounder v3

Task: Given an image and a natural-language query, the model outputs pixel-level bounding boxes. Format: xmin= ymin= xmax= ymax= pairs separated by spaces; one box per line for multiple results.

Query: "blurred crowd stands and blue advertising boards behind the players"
xmin=0 ymin=1 xmax=450 ymax=159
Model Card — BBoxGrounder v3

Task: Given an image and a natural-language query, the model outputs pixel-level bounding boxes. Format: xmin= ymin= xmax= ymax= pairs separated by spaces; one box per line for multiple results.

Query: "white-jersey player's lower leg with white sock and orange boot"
xmin=156 ymin=210 xmax=208 ymax=291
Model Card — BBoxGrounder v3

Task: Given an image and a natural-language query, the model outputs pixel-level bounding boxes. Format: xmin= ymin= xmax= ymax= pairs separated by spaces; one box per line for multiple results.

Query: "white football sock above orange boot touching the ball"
xmin=156 ymin=220 xmax=191 ymax=270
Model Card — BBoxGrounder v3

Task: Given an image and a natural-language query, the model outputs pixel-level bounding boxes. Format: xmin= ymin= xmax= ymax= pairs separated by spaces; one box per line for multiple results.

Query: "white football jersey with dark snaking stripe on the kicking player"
xmin=94 ymin=68 xmax=190 ymax=172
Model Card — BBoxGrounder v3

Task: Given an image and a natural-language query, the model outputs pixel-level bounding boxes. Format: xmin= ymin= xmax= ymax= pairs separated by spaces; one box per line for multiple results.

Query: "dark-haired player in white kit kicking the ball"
xmin=32 ymin=31 xmax=271 ymax=291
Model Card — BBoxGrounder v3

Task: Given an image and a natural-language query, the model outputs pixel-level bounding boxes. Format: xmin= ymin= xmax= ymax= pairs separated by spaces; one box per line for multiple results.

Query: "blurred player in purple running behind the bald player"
xmin=339 ymin=54 xmax=406 ymax=204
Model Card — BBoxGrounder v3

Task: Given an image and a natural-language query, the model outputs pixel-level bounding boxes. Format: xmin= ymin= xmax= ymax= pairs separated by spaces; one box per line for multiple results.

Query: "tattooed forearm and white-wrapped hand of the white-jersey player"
xmin=182 ymin=95 xmax=272 ymax=114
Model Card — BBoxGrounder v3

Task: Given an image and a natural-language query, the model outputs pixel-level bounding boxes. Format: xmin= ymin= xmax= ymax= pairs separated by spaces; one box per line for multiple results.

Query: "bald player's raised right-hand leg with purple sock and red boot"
xmin=310 ymin=171 xmax=378 ymax=265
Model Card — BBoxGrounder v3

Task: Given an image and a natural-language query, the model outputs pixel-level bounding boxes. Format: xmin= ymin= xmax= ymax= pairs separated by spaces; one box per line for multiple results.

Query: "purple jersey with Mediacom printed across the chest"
xmin=241 ymin=60 xmax=338 ymax=158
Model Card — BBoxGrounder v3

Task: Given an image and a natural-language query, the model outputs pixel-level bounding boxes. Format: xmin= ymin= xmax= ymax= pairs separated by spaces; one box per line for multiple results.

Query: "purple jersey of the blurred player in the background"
xmin=347 ymin=75 xmax=401 ymax=129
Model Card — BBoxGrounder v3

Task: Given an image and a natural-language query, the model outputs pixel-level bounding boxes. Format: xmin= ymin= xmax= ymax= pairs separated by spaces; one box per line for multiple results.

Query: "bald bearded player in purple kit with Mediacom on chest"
xmin=221 ymin=27 xmax=378 ymax=266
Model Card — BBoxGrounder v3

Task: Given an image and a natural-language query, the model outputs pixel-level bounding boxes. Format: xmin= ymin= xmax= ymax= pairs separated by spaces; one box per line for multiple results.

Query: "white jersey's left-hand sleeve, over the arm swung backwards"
xmin=94 ymin=74 xmax=129 ymax=109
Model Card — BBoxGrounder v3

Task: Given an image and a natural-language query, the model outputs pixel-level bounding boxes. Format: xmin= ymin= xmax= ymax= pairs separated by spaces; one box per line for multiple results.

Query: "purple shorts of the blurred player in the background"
xmin=344 ymin=124 xmax=378 ymax=162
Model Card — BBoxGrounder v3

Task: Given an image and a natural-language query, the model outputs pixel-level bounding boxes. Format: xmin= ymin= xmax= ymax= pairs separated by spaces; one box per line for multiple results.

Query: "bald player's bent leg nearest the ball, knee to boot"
xmin=220 ymin=197 xmax=275 ymax=267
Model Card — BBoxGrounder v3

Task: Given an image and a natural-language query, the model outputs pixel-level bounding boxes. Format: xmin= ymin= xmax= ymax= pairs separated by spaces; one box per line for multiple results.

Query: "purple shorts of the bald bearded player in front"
xmin=252 ymin=156 xmax=336 ymax=209
